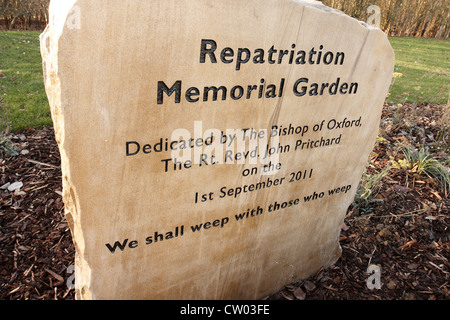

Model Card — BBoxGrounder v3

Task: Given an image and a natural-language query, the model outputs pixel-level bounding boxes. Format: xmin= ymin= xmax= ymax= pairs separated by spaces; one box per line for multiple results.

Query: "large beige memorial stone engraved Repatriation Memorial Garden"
xmin=41 ymin=0 xmax=394 ymax=299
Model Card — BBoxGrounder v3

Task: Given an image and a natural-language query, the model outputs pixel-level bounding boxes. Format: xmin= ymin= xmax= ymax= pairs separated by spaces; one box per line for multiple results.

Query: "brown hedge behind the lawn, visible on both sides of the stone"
xmin=0 ymin=0 xmax=450 ymax=39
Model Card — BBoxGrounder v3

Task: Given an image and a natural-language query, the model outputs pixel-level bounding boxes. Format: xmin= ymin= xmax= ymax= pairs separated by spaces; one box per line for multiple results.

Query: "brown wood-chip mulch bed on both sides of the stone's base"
xmin=0 ymin=105 xmax=450 ymax=300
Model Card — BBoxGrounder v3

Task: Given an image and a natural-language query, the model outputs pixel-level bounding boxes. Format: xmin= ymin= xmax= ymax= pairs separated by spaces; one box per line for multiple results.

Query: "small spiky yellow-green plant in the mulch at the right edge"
xmin=390 ymin=146 xmax=450 ymax=196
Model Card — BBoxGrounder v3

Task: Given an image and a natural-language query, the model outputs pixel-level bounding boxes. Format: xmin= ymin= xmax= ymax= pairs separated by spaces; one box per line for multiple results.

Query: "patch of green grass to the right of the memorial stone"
xmin=387 ymin=38 xmax=450 ymax=104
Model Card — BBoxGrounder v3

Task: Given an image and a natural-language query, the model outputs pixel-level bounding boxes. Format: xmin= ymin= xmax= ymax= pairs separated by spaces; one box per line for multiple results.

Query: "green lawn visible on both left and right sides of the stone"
xmin=0 ymin=31 xmax=450 ymax=131
